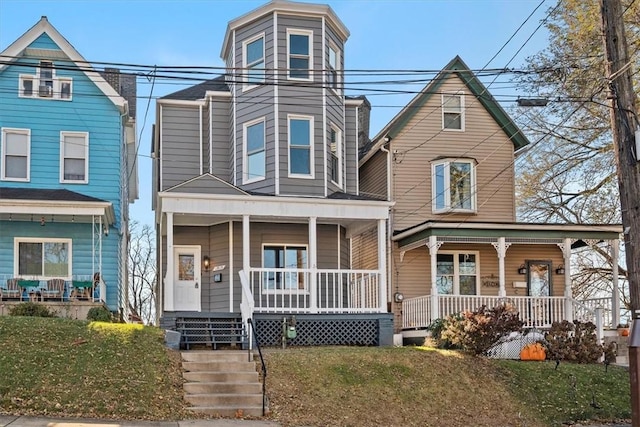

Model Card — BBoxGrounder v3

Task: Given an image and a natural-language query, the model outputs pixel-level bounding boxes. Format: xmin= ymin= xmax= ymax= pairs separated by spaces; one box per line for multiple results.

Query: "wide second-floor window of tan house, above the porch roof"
xmin=432 ymin=159 xmax=476 ymax=213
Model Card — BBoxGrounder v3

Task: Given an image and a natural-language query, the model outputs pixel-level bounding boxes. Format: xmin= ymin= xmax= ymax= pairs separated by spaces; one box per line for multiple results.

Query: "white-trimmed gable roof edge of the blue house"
xmin=0 ymin=16 xmax=128 ymax=111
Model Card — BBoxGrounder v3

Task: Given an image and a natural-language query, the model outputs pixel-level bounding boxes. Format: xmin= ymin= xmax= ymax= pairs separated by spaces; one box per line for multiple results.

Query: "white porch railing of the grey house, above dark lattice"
xmin=243 ymin=268 xmax=380 ymax=313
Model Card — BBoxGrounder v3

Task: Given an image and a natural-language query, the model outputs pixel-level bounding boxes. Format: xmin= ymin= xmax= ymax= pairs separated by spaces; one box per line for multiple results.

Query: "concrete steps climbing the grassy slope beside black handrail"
xmin=182 ymin=350 xmax=266 ymax=417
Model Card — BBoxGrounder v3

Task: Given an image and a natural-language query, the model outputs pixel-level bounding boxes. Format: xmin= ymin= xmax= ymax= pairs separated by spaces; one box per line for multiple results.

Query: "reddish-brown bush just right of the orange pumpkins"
xmin=543 ymin=320 xmax=605 ymax=363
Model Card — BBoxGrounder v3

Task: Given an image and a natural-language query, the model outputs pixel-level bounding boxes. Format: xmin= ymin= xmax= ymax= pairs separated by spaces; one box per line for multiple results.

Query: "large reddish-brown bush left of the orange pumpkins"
xmin=440 ymin=304 xmax=523 ymax=355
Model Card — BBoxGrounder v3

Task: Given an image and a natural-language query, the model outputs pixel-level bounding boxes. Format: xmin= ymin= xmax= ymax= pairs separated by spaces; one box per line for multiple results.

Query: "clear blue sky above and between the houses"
xmin=0 ymin=0 xmax=555 ymax=224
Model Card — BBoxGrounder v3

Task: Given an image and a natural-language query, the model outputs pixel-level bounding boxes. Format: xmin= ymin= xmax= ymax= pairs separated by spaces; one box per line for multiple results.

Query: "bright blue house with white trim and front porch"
xmin=0 ymin=17 xmax=138 ymax=318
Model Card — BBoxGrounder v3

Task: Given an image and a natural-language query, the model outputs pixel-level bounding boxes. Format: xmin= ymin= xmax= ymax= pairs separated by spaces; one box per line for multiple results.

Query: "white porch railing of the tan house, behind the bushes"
xmin=402 ymin=295 xmax=606 ymax=329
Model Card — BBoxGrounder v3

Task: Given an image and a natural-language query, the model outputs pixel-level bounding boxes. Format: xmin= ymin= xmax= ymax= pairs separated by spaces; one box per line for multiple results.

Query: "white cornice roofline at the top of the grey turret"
xmin=220 ymin=0 xmax=350 ymax=60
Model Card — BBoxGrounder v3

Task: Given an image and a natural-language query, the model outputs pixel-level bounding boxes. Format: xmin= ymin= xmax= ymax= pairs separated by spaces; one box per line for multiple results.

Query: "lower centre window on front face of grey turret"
xmin=289 ymin=116 xmax=313 ymax=177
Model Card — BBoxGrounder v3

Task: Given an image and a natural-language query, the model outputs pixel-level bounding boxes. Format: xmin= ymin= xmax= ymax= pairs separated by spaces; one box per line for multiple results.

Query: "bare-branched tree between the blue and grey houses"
xmin=129 ymin=221 xmax=158 ymax=324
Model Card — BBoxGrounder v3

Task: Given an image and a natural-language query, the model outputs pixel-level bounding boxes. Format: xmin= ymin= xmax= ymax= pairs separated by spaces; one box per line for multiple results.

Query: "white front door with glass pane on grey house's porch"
xmin=173 ymin=246 xmax=202 ymax=311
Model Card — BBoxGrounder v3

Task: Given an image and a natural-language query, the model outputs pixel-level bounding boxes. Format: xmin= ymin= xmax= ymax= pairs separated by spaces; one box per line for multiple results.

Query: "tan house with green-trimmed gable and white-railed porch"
xmin=353 ymin=57 xmax=622 ymax=340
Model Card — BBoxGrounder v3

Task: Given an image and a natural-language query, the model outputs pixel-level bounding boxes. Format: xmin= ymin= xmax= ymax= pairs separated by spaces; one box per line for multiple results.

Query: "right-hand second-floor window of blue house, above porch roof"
xmin=60 ymin=132 xmax=89 ymax=184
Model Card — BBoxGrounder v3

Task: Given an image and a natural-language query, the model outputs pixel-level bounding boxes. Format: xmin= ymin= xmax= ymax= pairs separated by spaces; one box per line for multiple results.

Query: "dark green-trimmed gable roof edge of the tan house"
xmin=360 ymin=56 xmax=529 ymax=164
